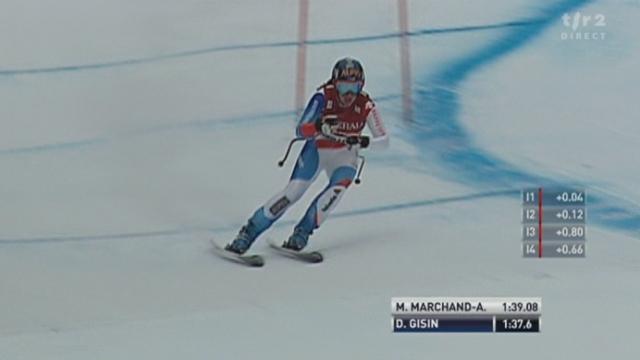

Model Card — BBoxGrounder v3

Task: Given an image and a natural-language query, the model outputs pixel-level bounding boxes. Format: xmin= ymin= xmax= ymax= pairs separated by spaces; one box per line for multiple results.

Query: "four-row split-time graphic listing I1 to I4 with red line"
xmin=522 ymin=188 xmax=587 ymax=258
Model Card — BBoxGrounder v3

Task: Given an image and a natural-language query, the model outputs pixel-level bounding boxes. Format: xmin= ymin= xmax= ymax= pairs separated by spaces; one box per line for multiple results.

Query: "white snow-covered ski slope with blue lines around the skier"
xmin=0 ymin=0 xmax=640 ymax=360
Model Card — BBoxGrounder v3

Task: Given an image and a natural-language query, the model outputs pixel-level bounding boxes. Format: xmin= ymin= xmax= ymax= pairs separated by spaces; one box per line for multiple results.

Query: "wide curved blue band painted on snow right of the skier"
xmin=404 ymin=0 xmax=640 ymax=236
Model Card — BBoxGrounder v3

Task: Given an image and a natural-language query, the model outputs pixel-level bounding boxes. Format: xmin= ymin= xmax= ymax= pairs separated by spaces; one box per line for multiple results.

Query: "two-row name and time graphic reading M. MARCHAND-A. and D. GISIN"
xmin=391 ymin=297 xmax=542 ymax=333
